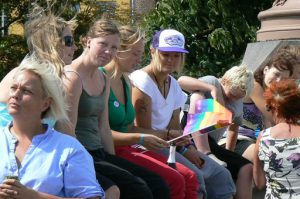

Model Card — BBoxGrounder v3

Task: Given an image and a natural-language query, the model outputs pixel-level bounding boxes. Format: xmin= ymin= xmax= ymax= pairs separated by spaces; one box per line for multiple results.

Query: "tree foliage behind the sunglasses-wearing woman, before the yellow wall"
xmin=0 ymin=0 xmax=140 ymax=80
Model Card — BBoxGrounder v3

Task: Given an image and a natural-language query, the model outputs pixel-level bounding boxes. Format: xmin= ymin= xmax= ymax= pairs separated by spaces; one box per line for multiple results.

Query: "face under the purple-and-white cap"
xmin=158 ymin=51 xmax=182 ymax=74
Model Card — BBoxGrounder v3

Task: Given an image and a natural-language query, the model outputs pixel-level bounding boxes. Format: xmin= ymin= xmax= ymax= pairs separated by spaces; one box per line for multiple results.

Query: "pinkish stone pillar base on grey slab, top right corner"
xmin=242 ymin=0 xmax=300 ymax=71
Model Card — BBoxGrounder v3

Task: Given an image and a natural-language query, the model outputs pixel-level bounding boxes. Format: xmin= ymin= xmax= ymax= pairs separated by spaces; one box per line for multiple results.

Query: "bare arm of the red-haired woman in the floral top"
xmin=253 ymin=133 xmax=266 ymax=189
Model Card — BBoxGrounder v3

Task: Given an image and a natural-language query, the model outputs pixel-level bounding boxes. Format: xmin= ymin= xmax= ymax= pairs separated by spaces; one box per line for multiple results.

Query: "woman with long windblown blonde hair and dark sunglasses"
xmin=0 ymin=4 xmax=77 ymax=126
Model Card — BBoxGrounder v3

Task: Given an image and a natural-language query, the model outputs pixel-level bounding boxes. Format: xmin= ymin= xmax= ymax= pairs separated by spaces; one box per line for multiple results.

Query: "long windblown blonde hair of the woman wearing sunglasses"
xmin=25 ymin=4 xmax=77 ymax=77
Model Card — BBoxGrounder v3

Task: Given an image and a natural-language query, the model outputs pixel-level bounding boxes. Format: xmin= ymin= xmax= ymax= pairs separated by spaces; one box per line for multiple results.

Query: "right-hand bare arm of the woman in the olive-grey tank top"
xmin=98 ymin=71 xmax=115 ymax=154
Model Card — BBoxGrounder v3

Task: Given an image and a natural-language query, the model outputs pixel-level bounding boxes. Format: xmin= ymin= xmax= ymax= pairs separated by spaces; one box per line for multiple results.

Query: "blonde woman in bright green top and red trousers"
xmin=100 ymin=26 xmax=202 ymax=198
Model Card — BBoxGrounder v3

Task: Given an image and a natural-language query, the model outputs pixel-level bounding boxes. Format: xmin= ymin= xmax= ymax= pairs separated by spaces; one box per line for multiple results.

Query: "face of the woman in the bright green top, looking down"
xmin=117 ymin=40 xmax=144 ymax=73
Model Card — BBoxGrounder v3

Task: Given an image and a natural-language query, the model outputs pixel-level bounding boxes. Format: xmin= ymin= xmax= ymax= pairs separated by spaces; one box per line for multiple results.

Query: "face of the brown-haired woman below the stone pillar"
xmin=264 ymin=66 xmax=290 ymax=87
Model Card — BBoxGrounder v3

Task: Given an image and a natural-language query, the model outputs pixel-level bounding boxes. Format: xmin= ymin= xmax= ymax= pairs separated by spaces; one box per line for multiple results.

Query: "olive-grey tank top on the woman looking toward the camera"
xmin=75 ymin=77 xmax=106 ymax=150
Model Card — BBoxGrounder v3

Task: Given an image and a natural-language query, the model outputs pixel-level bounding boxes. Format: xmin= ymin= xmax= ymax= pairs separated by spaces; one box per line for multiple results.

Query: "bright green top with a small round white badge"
xmin=99 ymin=67 xmax=135 ymax=133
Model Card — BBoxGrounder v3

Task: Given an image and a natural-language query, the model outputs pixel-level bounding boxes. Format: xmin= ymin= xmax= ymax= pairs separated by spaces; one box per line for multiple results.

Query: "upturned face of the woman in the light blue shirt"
xmin=7 ymin=71 xmax=51 ymax=120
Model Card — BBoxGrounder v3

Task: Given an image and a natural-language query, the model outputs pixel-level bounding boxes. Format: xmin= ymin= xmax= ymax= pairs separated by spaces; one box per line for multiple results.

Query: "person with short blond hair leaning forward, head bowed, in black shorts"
xmin=178 ymin=66 xmax=253 ymax=199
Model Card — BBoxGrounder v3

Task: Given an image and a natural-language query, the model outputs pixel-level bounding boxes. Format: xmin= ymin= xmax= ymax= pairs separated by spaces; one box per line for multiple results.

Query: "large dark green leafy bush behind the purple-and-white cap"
xmin=143 ymin=0 xmax=273 ymax=76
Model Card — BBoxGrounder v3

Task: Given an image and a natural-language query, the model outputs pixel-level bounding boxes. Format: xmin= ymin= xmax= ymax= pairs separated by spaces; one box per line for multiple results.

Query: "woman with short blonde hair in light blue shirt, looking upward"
xmin=0 ymin=57 xmax=104 ymax=199
